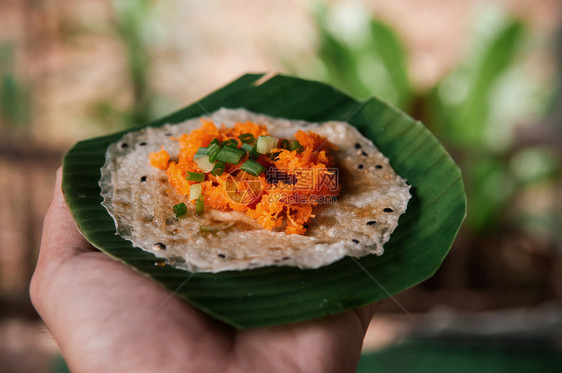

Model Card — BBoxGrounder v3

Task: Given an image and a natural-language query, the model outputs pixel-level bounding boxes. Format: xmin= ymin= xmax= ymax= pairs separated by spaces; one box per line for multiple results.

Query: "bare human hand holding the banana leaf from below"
xmin=30 ymin=169 xmax=373 ymax=372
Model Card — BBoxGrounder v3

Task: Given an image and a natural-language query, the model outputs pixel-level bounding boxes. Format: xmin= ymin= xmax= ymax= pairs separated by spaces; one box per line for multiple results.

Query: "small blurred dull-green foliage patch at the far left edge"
xmin=0 ymin=44 xmax=31 ymax=135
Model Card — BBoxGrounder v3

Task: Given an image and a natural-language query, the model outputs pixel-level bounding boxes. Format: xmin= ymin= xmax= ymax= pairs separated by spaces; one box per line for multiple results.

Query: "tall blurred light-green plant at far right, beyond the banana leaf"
xmin=426 ymin=9 xmax=560 ymax=232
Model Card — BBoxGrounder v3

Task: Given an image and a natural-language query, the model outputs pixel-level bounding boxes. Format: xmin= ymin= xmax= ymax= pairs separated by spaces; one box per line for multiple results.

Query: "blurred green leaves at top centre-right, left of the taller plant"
xmin=288 ymin=3 xmax=414 ymax=108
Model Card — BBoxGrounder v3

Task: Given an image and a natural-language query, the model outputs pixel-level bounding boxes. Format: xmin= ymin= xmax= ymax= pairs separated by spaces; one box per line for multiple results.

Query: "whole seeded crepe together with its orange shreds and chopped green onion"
xmin=100 ymin=109 xmax=410 ymax=272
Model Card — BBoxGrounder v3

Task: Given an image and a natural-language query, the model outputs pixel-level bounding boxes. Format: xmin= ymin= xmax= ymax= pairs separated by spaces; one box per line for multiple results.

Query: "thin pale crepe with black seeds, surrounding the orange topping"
xmin=100 ymin=109 xmax=410 ymax=272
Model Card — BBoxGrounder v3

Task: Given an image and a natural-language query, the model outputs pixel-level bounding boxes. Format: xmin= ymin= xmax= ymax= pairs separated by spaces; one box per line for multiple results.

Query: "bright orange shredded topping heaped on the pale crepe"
xmin=149 ymin=119 xmax=341 ymax=234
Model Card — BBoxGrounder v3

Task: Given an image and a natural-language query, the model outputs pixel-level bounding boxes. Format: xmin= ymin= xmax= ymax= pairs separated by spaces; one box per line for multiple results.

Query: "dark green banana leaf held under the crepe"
xmin=63 ymin=74 xmax=466 ymax=329
